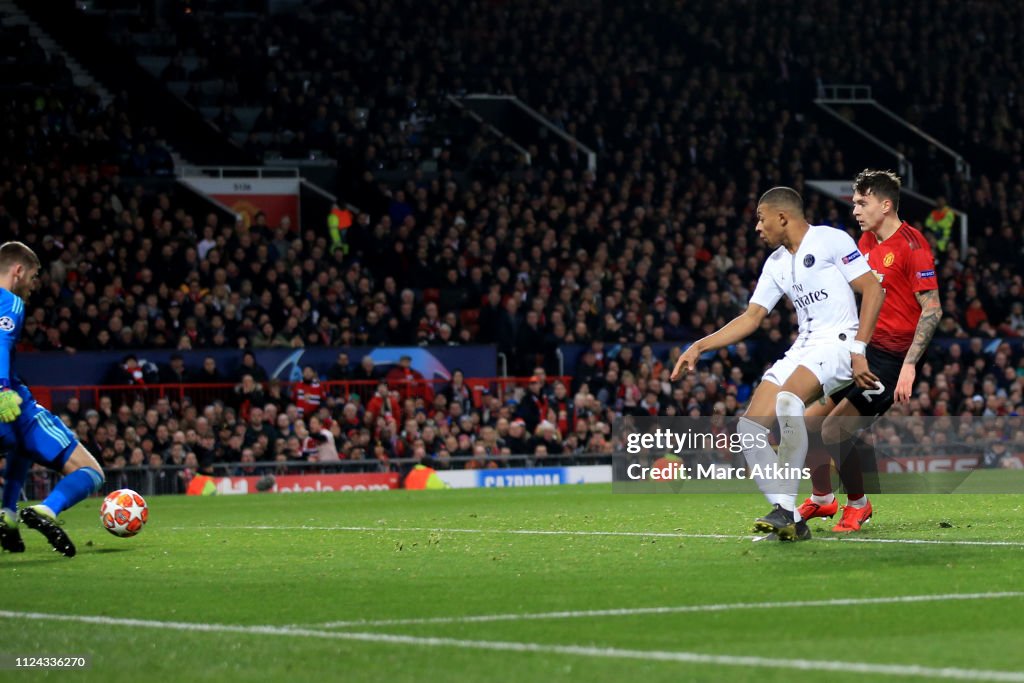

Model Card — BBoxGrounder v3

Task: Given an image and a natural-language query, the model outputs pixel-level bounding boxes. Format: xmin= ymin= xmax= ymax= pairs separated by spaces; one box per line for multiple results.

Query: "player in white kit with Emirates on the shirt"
xmin=672 ymin=187 xmax=885 ymax=541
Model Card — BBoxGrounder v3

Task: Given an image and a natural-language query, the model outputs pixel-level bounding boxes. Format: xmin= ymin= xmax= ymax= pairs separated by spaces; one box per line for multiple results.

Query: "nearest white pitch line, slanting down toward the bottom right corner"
xmin=0 ymin=610 xmax=1024 ymax=683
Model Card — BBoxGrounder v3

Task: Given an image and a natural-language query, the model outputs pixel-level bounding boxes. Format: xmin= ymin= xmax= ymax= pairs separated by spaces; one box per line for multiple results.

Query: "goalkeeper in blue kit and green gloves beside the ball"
xmin=0 ymin=242 xmax=103 ymax=557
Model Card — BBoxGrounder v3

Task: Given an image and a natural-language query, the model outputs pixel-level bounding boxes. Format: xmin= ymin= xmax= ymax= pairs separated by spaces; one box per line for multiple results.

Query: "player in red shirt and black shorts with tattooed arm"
xmin=800 ymin=169 xmax=942 ymax=532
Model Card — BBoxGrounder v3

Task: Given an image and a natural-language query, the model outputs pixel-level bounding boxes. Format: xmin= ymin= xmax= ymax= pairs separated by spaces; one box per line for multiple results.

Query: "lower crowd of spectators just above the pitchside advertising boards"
xmin=9 ymin=325 xmax=1024 ymax=493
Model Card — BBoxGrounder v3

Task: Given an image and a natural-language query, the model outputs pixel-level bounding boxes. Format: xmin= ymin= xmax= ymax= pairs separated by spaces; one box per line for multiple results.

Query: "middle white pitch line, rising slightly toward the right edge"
xmin=310 ymin=592 xmax=1024 ymax=629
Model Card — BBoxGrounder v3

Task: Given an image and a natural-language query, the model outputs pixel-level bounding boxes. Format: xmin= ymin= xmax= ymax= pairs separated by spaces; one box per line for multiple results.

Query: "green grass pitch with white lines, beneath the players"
xmin=0 ymin=485 xmax=1024 ymax=683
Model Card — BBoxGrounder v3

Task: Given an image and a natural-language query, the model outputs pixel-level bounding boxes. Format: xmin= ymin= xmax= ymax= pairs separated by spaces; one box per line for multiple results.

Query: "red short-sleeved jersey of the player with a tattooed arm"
xmin=857 ymin=222 xmax=939 ymax=355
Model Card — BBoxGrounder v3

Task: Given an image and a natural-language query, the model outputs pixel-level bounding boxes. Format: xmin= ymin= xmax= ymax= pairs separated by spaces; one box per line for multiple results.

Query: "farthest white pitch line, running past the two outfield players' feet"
xmin=178 ymin=525 xmax=1024 ymax=548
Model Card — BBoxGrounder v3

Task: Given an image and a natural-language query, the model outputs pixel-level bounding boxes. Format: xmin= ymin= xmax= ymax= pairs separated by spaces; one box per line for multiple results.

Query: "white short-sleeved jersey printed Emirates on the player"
xmin=751 ymin=225 xmax=870 ymax=348
